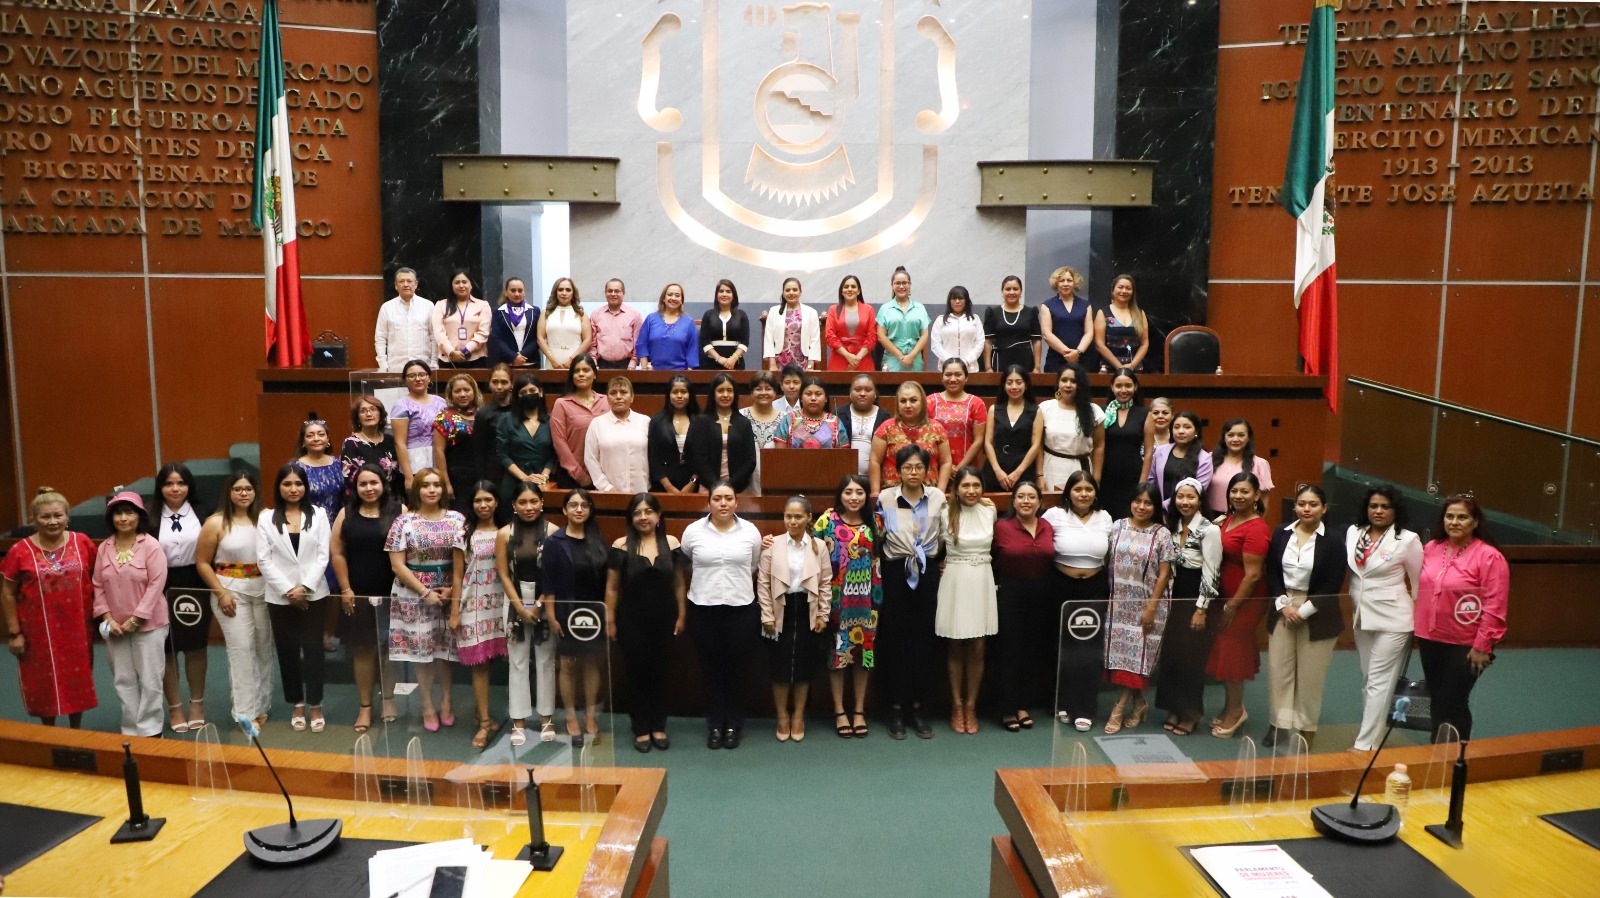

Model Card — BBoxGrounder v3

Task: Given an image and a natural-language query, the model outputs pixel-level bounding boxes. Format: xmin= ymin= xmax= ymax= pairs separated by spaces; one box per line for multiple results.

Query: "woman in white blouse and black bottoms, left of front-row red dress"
xmin=1155 ymin=477 xmax=1222 ymax=736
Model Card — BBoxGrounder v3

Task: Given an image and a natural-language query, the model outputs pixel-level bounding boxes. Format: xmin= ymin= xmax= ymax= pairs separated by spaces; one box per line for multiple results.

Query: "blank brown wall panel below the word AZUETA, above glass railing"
xmin=1440 ymin=285 xmax=1578 ymax=429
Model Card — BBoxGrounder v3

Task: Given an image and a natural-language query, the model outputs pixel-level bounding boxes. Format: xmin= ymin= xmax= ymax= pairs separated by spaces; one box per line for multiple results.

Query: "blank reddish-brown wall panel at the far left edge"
xmin=6 ymin=276 xmax=157 ymax=503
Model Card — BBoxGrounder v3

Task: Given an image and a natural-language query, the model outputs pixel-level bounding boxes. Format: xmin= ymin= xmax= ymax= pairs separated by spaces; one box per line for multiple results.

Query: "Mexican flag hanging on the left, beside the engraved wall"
xmin=250 ymin=0 xmax=310 ymax=368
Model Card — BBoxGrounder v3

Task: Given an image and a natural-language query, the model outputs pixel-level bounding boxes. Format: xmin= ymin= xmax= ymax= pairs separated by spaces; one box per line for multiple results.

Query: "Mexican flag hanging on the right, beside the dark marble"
xmin=1278 ymin=0 xmax=1339 ymax=411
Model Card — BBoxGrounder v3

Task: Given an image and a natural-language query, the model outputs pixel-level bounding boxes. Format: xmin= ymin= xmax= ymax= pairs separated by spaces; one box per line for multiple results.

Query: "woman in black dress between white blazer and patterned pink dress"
xmin=330 ymin=464 xmax=400 ymax=733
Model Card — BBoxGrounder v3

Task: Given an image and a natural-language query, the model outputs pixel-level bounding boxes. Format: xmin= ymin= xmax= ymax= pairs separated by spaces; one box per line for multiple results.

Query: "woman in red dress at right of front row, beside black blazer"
xmin=1205 ymin=471 xmax=1272 ymax=740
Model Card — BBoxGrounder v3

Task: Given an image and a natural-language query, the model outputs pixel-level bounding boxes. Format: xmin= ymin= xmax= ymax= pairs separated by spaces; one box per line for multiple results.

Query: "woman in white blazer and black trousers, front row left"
xmin=256 ymin=464 xmax=333 ymax=733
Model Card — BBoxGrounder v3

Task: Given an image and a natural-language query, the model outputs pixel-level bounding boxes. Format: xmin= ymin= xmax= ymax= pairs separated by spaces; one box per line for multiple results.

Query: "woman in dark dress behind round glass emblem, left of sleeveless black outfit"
xmin=539 ymin=487 xmax=606 ymax=746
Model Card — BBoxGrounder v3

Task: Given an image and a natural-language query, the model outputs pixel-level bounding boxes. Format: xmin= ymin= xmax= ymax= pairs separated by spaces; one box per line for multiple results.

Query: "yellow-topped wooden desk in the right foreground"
xmin=990 ymin=727 xmax=1600 ymax=898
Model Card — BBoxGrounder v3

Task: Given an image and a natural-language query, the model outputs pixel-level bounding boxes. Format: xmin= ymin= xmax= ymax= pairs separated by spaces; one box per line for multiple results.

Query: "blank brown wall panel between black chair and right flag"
xmin=1206 ymin=283 xmax=1299 ymax=375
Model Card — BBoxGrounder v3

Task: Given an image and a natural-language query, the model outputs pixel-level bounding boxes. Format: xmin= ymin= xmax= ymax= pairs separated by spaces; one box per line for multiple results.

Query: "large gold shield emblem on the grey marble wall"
xmin=638 ymin=0 xmax=960 ymax=271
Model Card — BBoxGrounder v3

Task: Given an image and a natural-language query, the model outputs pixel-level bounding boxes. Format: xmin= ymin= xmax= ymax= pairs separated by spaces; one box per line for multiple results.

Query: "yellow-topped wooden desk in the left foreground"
xmin=0 ymin=720 xmax=667 ymax=898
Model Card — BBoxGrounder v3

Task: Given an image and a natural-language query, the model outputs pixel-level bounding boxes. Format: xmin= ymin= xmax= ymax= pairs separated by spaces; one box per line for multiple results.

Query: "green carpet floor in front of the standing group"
xmin=0 ymin=648 xmax=1600 ymax=898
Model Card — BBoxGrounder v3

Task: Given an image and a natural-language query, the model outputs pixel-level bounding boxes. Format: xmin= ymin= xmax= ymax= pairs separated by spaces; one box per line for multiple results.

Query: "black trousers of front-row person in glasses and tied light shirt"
xmin=874 ymin=559 xmax=942 ymax=708
